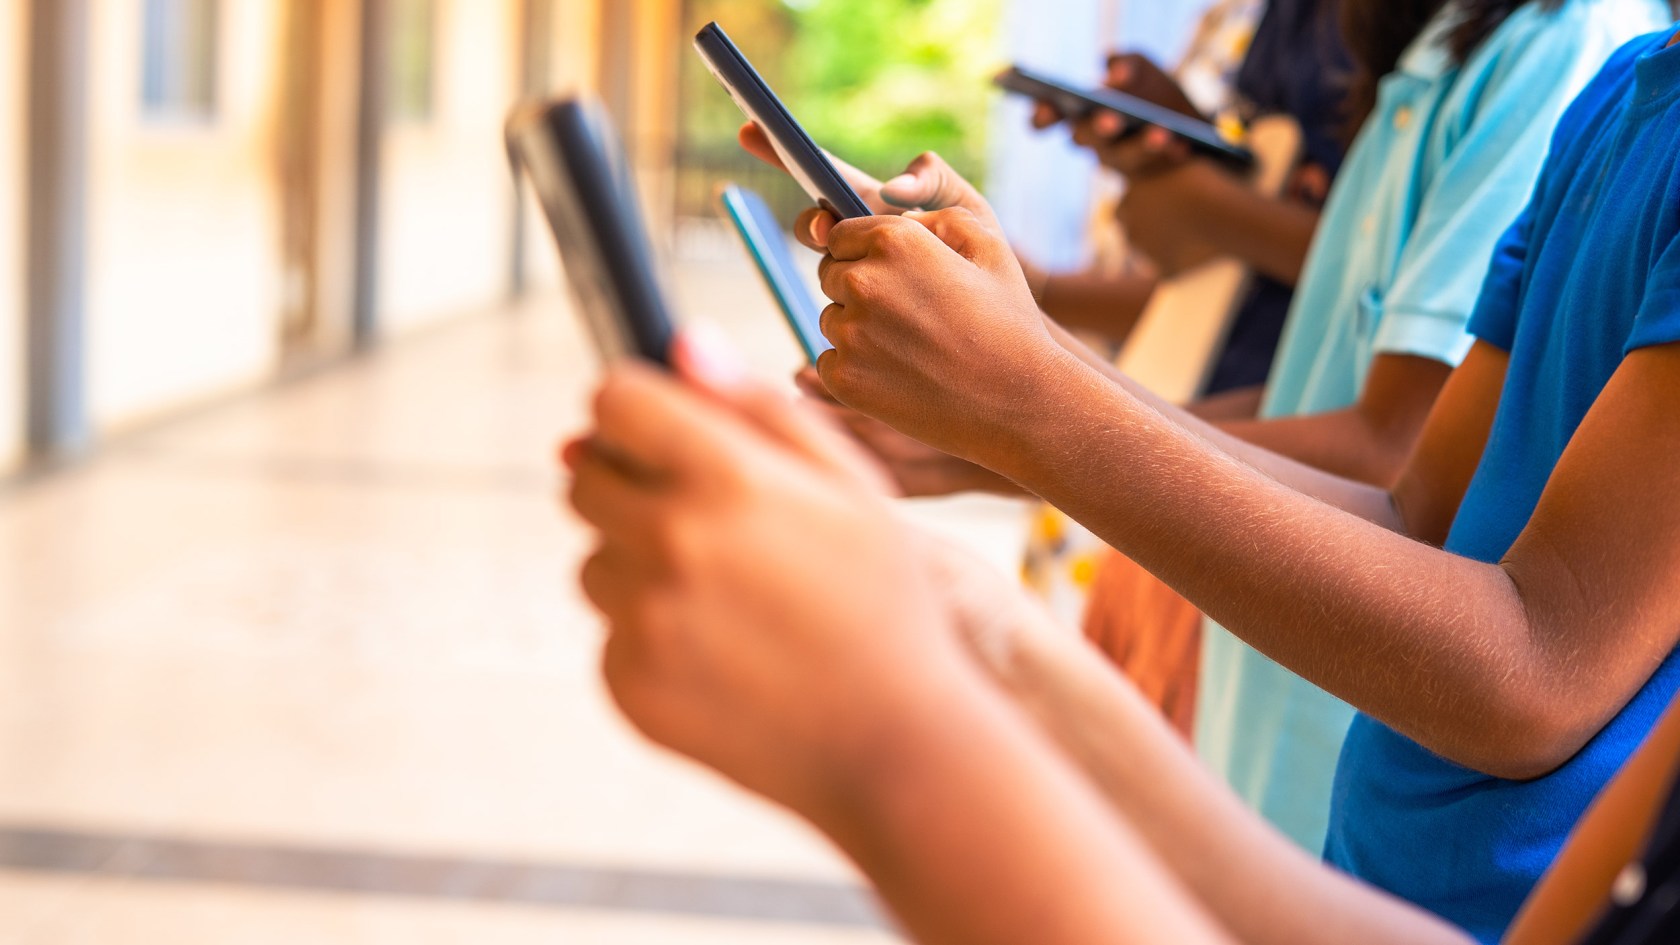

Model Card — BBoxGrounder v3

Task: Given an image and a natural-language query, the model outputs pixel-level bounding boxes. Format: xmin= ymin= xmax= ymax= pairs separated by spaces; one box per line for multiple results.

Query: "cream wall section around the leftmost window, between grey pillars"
xmin=87 ymin=0 xmax=286 ymax=432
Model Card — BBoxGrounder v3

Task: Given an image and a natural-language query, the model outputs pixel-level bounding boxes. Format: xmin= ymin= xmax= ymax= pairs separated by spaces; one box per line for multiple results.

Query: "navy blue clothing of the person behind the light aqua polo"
xmin=1206 ymin=0 xmax=1352 ymax=393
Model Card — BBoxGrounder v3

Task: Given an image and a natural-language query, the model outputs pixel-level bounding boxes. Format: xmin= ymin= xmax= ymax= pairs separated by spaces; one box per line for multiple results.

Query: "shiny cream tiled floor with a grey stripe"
xmin=0 ymin=253 xmax=1018 ymax=945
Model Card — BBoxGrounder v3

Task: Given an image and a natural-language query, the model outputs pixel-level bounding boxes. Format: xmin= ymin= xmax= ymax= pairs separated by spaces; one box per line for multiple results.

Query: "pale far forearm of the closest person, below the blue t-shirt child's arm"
xmin=1003 ymin=622 xmax=1468 ymax=945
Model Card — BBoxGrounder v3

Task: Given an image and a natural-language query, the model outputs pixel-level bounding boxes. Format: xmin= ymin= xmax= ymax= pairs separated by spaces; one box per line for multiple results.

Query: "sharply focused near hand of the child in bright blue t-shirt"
xmin=816 ymin=209 xmax=1067 ymax=461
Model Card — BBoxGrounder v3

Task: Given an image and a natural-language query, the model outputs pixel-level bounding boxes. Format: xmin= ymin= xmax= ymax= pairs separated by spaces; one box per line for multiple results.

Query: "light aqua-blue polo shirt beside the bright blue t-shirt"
xmin=1196 ymin=0 xmax=1670 ymax=853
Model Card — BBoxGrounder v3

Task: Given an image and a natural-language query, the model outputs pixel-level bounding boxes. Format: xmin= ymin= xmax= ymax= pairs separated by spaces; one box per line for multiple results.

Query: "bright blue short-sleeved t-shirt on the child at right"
xmin=1326 ymin=32 xmax=1680 ymax=942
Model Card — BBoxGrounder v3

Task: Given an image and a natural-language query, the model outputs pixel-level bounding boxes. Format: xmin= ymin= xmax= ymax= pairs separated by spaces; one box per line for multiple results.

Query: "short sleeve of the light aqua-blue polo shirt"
xmin=1376 ymin=13 xmax=1618 ymax=365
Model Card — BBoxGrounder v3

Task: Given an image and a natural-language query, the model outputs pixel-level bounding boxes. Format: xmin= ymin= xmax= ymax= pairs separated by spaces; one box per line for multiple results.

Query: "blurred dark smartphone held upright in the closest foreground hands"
xmin=506 ymin=99 xmax=675 ymax=359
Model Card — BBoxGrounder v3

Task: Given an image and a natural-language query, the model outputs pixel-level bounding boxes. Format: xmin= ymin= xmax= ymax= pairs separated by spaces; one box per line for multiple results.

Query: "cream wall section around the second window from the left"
xmin=380 ymin=0 xmax=521 ymax=335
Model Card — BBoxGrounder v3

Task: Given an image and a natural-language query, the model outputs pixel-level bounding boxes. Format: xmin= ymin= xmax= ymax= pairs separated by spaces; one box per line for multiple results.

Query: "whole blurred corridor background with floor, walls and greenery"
xmin=0 ymin=0 xmax=1198 ymax=943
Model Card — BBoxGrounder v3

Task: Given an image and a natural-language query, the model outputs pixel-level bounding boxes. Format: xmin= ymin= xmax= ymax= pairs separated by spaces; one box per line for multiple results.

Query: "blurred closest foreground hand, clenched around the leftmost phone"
xmin=563 ymin=326 xmax=974 ymax=812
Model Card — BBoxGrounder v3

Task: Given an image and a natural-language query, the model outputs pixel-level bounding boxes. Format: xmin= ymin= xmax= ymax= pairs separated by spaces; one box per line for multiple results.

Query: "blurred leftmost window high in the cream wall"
xmin=141 ymin=0 xmax=220 ymax=121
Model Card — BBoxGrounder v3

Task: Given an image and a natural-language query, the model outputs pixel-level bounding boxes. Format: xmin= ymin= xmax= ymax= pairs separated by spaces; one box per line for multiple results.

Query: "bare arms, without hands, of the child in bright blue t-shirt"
xmin=981 ymin=334 xmax=1680 ymax=779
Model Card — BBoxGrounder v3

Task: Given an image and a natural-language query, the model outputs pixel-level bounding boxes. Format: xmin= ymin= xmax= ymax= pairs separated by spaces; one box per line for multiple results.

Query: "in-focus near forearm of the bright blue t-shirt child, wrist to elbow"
xmin=973 ymin=346 xmax=1591 ymax=777
